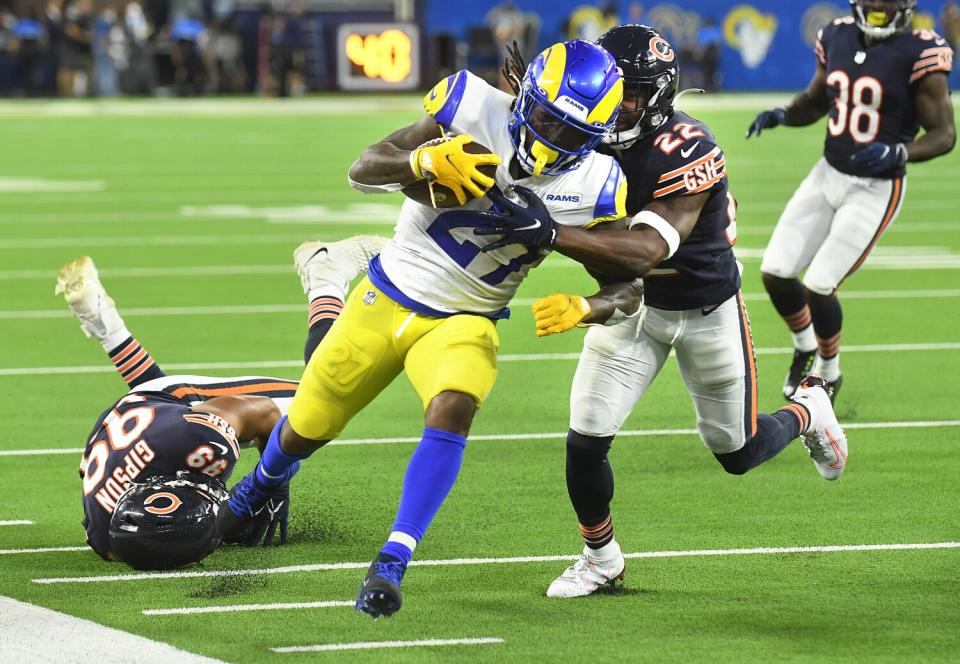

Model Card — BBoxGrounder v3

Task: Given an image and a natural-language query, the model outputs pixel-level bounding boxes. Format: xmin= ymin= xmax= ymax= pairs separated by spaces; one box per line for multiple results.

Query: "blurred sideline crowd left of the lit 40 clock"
xmin=0 ymin=0 xmax=304 ymax=97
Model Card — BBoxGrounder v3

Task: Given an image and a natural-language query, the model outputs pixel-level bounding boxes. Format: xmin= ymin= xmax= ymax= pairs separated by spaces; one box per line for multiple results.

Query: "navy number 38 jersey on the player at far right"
xmin=815 ymin=16 xmax=953 ymax=179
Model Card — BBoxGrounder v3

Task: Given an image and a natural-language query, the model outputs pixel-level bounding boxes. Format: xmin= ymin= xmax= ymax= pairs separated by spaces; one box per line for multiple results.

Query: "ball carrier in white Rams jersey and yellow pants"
xmin=221 ymin=41 xmax=639 ymax=617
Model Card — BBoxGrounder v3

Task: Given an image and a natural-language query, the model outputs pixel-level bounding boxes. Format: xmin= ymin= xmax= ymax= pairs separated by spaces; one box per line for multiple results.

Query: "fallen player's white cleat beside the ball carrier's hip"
xmin=293 ymin=235 xmax=389 ymax=294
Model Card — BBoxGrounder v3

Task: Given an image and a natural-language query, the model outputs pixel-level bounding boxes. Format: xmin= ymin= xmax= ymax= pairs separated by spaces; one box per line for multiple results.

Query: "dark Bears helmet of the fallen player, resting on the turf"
xmin=109 ymin=470 xmax=229 ymax=569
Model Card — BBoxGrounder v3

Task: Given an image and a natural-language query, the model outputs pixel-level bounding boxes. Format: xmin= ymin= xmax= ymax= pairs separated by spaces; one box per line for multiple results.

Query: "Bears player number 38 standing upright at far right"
xmin=747 ymin=0 xmax=956 ymax=399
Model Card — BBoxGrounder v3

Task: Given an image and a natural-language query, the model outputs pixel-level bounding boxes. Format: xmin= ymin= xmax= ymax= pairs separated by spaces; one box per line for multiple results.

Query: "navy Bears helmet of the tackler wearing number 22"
xmin=597 ymin=25 xmax=680 ymax=148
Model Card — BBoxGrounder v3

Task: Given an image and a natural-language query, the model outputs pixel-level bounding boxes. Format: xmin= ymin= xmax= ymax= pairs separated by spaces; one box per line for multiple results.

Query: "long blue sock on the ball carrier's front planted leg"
xmin=380 ymin=427 xmax=467 ymax=565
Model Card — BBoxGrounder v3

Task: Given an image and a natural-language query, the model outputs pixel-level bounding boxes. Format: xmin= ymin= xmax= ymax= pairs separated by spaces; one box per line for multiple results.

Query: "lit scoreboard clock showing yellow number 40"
xmin=337 ymin=23 xmax=420 ymax=90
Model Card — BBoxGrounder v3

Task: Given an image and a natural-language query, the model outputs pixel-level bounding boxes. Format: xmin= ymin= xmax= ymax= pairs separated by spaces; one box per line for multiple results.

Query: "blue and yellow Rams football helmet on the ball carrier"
xmin=510 ymin=39 xmax=623 ymax=175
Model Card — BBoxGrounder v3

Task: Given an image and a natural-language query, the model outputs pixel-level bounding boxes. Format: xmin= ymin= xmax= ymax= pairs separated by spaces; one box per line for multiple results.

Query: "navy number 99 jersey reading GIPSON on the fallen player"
xmin=80 ymin=392 xmax=240 ymax=559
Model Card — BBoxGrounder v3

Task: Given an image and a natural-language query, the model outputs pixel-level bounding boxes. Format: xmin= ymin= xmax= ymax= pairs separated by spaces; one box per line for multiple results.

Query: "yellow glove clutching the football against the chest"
xmin=410 ymin=134 xmax=500 ymax=205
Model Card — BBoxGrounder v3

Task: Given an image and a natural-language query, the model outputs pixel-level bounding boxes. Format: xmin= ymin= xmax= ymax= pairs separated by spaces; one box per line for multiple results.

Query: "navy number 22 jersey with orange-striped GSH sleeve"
xmin=612 ymin=111 xmax=740 ymax=311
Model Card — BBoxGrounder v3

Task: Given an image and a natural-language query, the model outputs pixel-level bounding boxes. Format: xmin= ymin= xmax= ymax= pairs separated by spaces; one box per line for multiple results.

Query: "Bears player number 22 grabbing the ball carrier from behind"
xmin=488 ymin=25 xmax=847 ymax=598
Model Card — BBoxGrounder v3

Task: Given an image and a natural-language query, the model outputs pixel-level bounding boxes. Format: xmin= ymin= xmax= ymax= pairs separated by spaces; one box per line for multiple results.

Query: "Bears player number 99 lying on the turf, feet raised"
xmin=56 ymin=236 xmax=386 ymax=569
